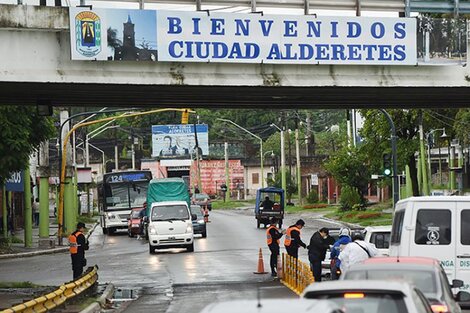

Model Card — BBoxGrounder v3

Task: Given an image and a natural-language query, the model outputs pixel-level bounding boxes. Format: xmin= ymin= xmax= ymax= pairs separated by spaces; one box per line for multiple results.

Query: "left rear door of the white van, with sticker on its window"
xmin=410 ymin=201 xmax=456 ymax=281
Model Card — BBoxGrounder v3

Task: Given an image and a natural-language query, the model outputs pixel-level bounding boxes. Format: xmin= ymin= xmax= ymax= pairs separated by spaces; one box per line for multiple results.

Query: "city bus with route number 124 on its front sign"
xmin=97 ymin=170 xmax=152 ymax=234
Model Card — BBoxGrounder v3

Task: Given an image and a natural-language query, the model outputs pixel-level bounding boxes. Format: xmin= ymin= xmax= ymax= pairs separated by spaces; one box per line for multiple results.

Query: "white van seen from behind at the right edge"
xmin=390 ymin=196 xmax=470 ymax=291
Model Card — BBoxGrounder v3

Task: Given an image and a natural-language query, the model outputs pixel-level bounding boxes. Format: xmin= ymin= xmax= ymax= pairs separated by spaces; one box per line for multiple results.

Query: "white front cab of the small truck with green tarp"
xmin=148 ymin=201 xmax=197 ymax=253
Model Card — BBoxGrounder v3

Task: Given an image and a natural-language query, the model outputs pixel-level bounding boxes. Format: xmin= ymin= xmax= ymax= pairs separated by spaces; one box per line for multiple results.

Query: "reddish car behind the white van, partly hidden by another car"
xmin=340 ymin=257 xmax=470 ymax=313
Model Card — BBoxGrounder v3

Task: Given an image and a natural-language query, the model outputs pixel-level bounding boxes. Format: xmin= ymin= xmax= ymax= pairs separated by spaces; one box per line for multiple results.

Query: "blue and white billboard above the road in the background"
xmin=152 ymin=124 xmax=209 ymax=158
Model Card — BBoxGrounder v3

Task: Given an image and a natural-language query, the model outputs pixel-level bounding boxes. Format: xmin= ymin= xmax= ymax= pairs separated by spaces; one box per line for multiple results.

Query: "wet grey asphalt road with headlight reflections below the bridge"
xmin=0 ymin=210 xmax=338 ymax=313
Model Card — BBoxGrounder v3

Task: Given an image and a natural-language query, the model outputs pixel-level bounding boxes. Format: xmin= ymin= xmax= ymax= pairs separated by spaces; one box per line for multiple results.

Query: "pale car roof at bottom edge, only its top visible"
xmin=200 ymin=299 xmax=344 ymax=313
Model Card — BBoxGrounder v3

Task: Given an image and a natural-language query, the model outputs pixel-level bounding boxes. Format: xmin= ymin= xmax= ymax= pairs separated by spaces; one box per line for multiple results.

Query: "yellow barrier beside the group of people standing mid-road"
xmin=281 ymin=253 xmax=315 ymax=295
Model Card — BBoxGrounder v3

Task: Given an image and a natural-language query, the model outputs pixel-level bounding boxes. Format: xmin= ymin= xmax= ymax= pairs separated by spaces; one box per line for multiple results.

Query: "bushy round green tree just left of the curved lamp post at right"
xmin=324 ymin=147 xmax=371 ymax=204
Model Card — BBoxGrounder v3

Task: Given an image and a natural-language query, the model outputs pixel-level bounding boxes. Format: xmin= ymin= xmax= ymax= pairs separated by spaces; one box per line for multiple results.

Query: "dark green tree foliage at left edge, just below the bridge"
xmin=0 ymin=106 xmax=54 ymax=183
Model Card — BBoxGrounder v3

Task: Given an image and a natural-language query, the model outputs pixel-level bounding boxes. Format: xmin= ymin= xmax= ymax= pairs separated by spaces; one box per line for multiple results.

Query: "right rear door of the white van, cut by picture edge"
xmin=455 ymin=202 xmax=470 ymax=291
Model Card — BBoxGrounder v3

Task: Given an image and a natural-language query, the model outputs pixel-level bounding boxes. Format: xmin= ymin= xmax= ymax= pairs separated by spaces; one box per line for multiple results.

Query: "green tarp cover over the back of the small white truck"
xmin=147 ymin=177 xmax=191 ymax=216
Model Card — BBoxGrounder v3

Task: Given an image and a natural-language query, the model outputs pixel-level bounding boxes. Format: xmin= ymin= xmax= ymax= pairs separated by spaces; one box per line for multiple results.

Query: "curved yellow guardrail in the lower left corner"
xmin=0 ymin=265 xmax=98 ymax=313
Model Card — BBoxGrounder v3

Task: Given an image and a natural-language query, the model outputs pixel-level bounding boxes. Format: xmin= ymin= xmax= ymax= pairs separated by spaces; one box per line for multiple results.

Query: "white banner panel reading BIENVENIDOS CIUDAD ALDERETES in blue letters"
xmin=157 ymin=11 xmax=417 ymax=65
